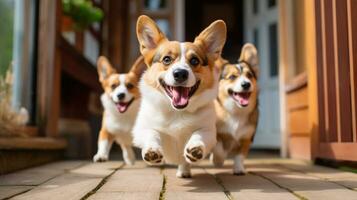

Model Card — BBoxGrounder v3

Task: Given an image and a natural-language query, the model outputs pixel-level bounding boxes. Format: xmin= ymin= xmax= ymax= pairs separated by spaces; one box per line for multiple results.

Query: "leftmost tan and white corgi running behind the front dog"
xmin=93 ymin=56 xmax=146 ymax=165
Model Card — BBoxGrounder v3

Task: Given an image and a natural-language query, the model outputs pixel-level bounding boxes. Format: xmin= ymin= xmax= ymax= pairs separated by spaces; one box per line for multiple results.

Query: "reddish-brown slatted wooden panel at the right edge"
xmin=313 ymin=0 xmax=357 ymax=161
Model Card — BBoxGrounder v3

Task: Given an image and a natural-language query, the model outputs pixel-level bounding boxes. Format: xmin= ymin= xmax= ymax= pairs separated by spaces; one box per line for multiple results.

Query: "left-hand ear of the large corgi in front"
xmin=136 ymin=15 xmax=167 ymax=54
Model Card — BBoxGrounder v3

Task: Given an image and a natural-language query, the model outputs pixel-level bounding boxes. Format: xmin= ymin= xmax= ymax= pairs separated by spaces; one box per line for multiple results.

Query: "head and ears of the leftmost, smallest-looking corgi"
xmin=97 ymin=56 xmax=146 ymax=113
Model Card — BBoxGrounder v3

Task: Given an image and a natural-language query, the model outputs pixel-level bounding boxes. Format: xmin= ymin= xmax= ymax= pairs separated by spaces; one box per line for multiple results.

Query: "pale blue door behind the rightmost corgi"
xmin=244 ymin=0 xmax=281 ymax=148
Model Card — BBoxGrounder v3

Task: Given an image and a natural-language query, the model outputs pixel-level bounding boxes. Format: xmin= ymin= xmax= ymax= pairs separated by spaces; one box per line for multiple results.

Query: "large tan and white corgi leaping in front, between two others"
xmin=133 ymin=15 xmax=226 ymax=178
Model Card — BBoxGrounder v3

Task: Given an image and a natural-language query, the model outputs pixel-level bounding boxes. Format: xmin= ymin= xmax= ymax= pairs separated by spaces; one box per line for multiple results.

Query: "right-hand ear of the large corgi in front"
xmin=194 ymin=20 xmax=227 ymax=59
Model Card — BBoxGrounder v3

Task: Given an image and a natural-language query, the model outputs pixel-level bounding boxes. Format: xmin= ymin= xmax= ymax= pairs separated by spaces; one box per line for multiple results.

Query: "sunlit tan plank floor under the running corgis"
xmin=0 ymin=158 xmax=357 ymax=200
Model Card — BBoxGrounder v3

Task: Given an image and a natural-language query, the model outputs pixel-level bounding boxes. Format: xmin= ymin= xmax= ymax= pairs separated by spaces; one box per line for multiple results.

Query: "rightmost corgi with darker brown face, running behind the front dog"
xmin=211 ymin=44 xmax=259 ymax=175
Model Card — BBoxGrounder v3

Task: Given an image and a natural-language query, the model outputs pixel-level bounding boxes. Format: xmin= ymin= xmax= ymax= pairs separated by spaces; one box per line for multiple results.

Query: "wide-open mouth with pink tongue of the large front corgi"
xmin=160 ymin=79 xmax=201 ymax=109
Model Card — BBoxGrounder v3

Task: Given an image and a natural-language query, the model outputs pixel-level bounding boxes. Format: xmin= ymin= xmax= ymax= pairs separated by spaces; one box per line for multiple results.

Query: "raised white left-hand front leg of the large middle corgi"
xmin=141 ymin=130 xmax=164 ymax=165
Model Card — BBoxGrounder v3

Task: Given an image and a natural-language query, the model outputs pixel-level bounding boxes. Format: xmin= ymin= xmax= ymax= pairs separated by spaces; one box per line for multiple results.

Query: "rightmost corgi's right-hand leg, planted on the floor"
xmin=233 ymin=138 xmax=251 ymax=176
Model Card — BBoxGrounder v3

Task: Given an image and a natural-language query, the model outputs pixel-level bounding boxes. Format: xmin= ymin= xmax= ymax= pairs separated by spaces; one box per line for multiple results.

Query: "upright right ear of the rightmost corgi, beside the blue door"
xmin=238 ymin=43 xmax=259 ymax=77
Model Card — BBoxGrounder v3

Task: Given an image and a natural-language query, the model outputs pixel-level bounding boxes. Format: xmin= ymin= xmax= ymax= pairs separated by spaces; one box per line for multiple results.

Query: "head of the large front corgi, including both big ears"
xmin=137 ymin=16 xmax=226 ymax=110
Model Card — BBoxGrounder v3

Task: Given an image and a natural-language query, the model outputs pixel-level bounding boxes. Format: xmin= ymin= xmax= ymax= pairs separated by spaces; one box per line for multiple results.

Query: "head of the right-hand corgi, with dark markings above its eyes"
xmin=219 ymin=44 xmax=258 ymax=108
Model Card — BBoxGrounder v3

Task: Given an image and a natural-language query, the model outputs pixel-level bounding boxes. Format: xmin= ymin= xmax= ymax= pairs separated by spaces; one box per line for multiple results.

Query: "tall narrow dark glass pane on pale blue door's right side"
xmin=269 ymin=23 xmax=278 ymax=77
